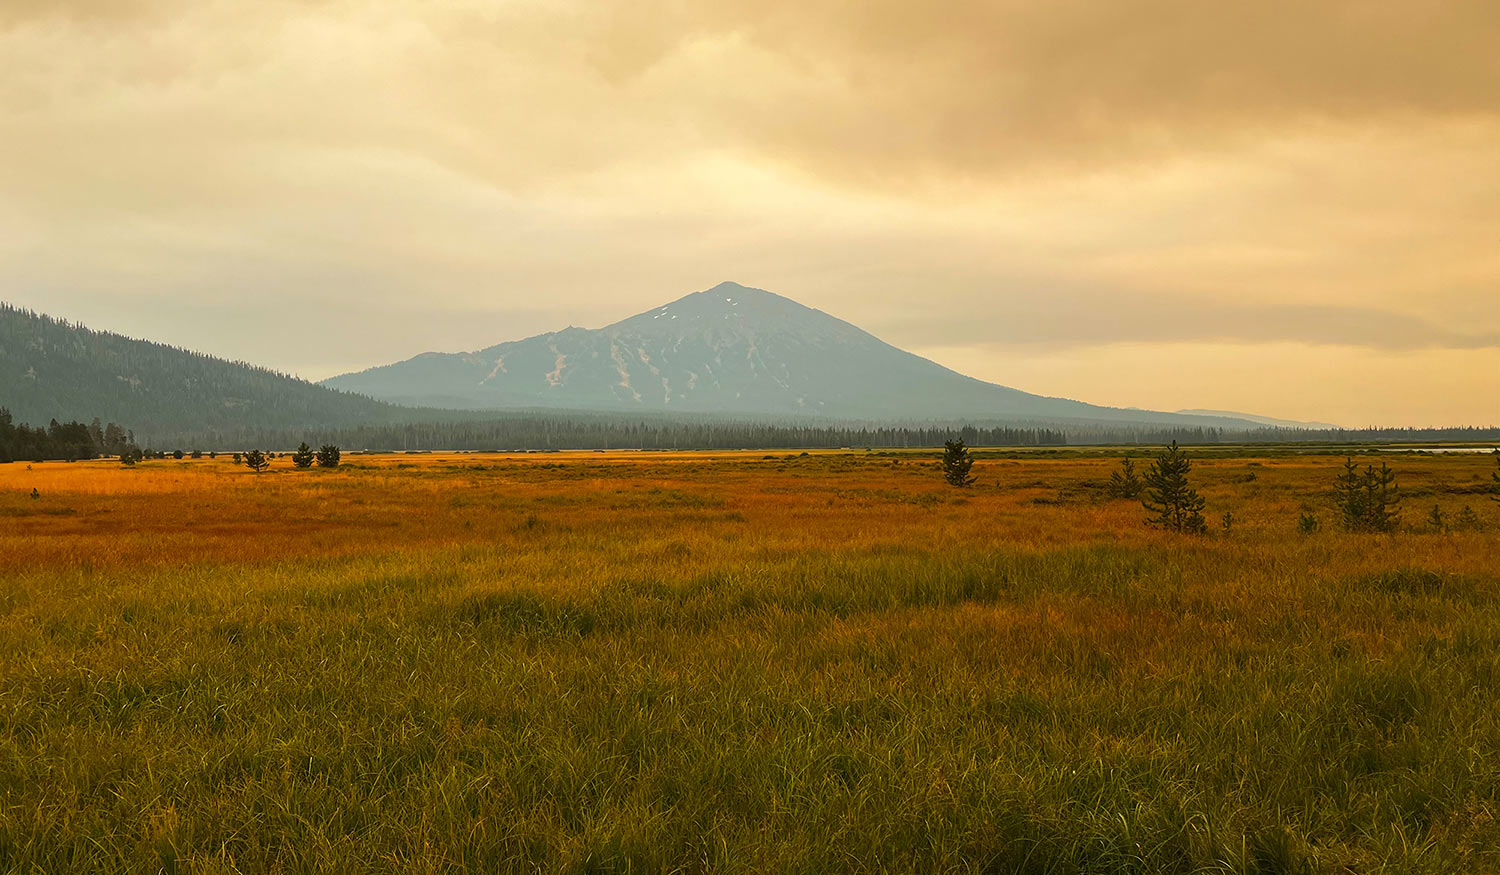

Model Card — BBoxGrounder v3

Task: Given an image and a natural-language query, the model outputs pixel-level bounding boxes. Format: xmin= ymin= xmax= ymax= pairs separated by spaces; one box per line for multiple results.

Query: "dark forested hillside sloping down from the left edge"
xmin=0 ymin=305 xmax=408 ymax=440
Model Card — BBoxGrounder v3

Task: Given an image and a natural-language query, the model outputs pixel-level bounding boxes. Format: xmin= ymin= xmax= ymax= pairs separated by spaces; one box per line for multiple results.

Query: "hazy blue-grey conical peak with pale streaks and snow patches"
xmin=323 ymin=282 xmax=1266 ymax=429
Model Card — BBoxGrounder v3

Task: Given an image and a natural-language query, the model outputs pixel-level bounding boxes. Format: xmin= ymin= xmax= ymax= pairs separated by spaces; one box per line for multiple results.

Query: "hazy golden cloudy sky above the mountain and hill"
xmin=0 ymin=0 xmax=1500 ymax=426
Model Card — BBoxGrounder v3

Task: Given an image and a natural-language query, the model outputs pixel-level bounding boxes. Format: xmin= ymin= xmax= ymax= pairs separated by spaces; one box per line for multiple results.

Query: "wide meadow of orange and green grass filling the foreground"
xmin=0 ymin=450 xmax=1500 ymax=875
